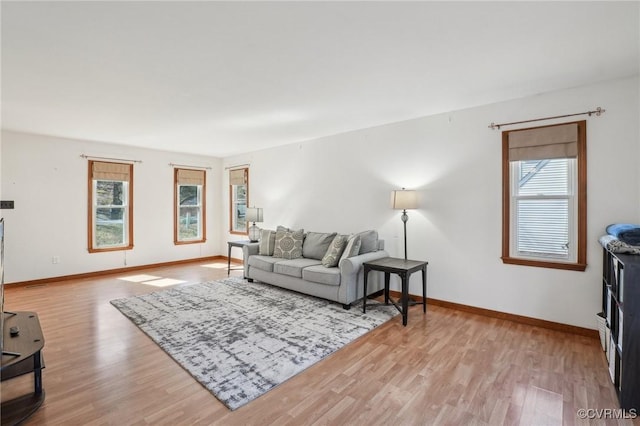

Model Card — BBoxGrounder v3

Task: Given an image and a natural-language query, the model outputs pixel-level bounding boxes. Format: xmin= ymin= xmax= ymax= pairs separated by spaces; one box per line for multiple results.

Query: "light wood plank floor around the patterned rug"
xmin=2 ymin=262 xmax=634 ymax=425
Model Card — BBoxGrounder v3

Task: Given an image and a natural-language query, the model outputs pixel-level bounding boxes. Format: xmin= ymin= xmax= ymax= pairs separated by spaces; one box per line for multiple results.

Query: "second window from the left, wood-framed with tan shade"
xmin=173 ymin=169 xmax=206 ymax=244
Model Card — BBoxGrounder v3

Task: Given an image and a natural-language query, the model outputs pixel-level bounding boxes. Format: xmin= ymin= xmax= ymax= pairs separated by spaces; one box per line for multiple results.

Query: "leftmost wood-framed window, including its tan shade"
xmin=88 ymin=160 xmax=133 ymax=253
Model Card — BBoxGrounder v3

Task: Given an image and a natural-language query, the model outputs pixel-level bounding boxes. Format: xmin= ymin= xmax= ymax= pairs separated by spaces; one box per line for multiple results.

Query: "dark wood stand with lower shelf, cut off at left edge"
xmin=0 ymin=312 xmax=44 ymax=425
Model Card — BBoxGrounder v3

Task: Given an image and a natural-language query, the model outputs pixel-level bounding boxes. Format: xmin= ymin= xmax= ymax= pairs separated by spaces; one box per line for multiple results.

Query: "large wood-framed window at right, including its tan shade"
xmin=502 ymin=121 xmax=587 ymax=271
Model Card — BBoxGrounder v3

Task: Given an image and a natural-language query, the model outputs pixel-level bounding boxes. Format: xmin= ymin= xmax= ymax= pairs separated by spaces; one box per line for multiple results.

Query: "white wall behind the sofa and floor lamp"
xmin=223 ymin=77 xmax=640 ymax=328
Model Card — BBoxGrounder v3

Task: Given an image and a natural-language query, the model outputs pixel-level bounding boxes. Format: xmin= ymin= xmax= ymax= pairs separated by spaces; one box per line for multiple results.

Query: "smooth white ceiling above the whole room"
xmin=1 ymin=1 xmax=640 ymax=157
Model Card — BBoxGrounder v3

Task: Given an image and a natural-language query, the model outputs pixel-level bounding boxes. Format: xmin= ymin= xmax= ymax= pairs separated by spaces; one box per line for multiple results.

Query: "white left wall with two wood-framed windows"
xmin=2 ymin=131 xmax=224 ymax=283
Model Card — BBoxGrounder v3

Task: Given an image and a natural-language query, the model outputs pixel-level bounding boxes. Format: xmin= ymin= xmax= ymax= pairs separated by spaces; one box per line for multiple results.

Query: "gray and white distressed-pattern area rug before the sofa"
xmin=111 ymin=278 xmax=398 ymax=410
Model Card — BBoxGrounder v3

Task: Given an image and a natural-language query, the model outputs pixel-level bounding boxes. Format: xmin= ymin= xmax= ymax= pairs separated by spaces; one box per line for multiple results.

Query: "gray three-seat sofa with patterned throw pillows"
xmin=242 ymin=227 xmax=389 ymax=309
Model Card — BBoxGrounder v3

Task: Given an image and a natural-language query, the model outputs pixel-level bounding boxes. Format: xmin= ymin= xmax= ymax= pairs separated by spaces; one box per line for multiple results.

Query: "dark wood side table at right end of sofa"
xmin=362 ymin=257 xmax=429 ymax=326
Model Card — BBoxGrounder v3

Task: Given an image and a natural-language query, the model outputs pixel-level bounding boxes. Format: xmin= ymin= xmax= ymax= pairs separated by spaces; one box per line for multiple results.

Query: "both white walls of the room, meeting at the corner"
xmin=0 ymin=77 xmax=640 ymax=328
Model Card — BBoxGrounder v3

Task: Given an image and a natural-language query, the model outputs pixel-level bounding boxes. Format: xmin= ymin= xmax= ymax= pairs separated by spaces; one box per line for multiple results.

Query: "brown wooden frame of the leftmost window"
xmin=87 ymin=160 xmax=133 ymax=253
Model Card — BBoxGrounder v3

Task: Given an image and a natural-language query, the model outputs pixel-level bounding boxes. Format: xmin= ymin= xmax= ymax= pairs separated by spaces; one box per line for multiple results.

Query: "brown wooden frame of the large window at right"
xmin=501 ymin=120 xmax=587 ymax=271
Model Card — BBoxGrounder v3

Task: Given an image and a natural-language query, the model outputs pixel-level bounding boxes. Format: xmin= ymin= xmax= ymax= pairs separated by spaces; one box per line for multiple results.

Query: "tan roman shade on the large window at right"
xmin=509 ymin=123 xmax=578 ymax=161
